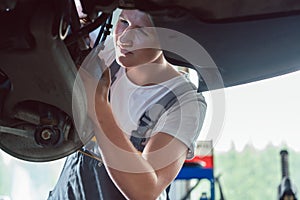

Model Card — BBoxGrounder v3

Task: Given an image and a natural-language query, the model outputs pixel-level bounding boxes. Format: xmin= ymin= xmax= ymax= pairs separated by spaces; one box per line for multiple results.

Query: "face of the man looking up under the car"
xmin=114 ymin=10 xmax=162 ymax=67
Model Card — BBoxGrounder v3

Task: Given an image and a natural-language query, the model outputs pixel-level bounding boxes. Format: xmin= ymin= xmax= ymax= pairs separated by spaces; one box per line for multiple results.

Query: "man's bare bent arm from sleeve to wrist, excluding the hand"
xmin=95 ymin=101 xmax=187 ymax=199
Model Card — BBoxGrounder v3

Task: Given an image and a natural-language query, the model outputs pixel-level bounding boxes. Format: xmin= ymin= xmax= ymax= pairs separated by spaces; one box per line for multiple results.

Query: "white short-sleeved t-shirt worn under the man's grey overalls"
xmin=110 ymin=67 xmax=206 ymax=159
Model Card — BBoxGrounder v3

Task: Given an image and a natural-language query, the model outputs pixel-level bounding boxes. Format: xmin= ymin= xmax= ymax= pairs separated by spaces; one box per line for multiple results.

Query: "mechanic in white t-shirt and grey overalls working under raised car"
xmin=48 ymin=10 xmax=206 ymax=200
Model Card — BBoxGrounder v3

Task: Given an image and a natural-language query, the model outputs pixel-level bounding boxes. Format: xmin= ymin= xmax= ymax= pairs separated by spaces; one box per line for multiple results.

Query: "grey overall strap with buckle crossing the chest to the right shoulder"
xmin=130 ymin=82 xmax=197 ymax=152
